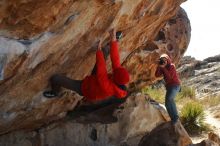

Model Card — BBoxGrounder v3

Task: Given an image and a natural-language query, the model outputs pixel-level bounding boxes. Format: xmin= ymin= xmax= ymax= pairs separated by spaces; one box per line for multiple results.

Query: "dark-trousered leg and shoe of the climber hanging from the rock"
xmin=43 ymin=74 xmax=82 ymax=98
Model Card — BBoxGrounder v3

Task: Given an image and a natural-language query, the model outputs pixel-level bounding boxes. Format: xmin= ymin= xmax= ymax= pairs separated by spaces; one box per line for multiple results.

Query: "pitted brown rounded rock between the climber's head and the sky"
xmin=124 ymin=9 xmax=190 ymax=90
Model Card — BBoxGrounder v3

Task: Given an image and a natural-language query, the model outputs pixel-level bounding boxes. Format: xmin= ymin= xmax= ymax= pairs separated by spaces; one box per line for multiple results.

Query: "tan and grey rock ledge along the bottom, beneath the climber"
xmin=0 ymin=94 xmax=191 ymax=146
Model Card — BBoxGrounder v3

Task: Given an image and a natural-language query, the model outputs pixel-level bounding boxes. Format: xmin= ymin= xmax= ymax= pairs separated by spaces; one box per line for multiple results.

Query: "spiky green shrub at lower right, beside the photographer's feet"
xmin=180 ymin=101 xmax=207 ymax=134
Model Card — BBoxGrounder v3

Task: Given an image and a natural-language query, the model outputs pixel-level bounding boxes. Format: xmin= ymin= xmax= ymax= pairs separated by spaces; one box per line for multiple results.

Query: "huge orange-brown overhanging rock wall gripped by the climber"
xmin=0 ymin=0 xmax=190 ymax=138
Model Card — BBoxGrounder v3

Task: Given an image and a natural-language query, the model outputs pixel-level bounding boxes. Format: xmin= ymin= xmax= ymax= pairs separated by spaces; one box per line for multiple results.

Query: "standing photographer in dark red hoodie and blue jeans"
xmin=155 ymin=54 xmax=180 ymax=124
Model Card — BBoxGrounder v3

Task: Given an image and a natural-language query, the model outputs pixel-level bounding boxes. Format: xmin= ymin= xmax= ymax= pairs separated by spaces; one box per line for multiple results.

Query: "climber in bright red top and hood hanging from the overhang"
xmin=43 ymin=29 xmax=129 ymax=102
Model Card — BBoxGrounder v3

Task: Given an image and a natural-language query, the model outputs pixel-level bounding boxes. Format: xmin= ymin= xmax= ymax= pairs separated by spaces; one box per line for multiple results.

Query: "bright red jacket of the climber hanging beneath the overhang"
xmin=81 ymin=41 xmax=127 ymax=101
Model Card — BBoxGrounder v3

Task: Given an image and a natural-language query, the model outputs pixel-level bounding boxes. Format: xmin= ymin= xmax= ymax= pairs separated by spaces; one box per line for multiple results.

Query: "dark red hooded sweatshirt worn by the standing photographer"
xmin=155 ymin=54 xmax=180 ymax=87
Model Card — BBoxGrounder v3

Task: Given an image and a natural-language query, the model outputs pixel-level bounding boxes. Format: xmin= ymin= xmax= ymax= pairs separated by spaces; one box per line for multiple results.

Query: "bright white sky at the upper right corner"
xmin=181 ymin=0 xmax=220 ymax=60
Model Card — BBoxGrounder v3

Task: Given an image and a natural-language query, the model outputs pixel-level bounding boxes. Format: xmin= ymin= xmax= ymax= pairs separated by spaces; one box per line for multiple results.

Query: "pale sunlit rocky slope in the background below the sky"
xmin=178 ymin=55 xmax=220 ymax=98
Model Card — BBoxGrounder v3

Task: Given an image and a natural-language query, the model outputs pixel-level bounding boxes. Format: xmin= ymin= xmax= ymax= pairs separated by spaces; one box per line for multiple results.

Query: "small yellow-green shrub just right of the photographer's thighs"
xmin=178 ymin=86 xmax=196 ymax=99
